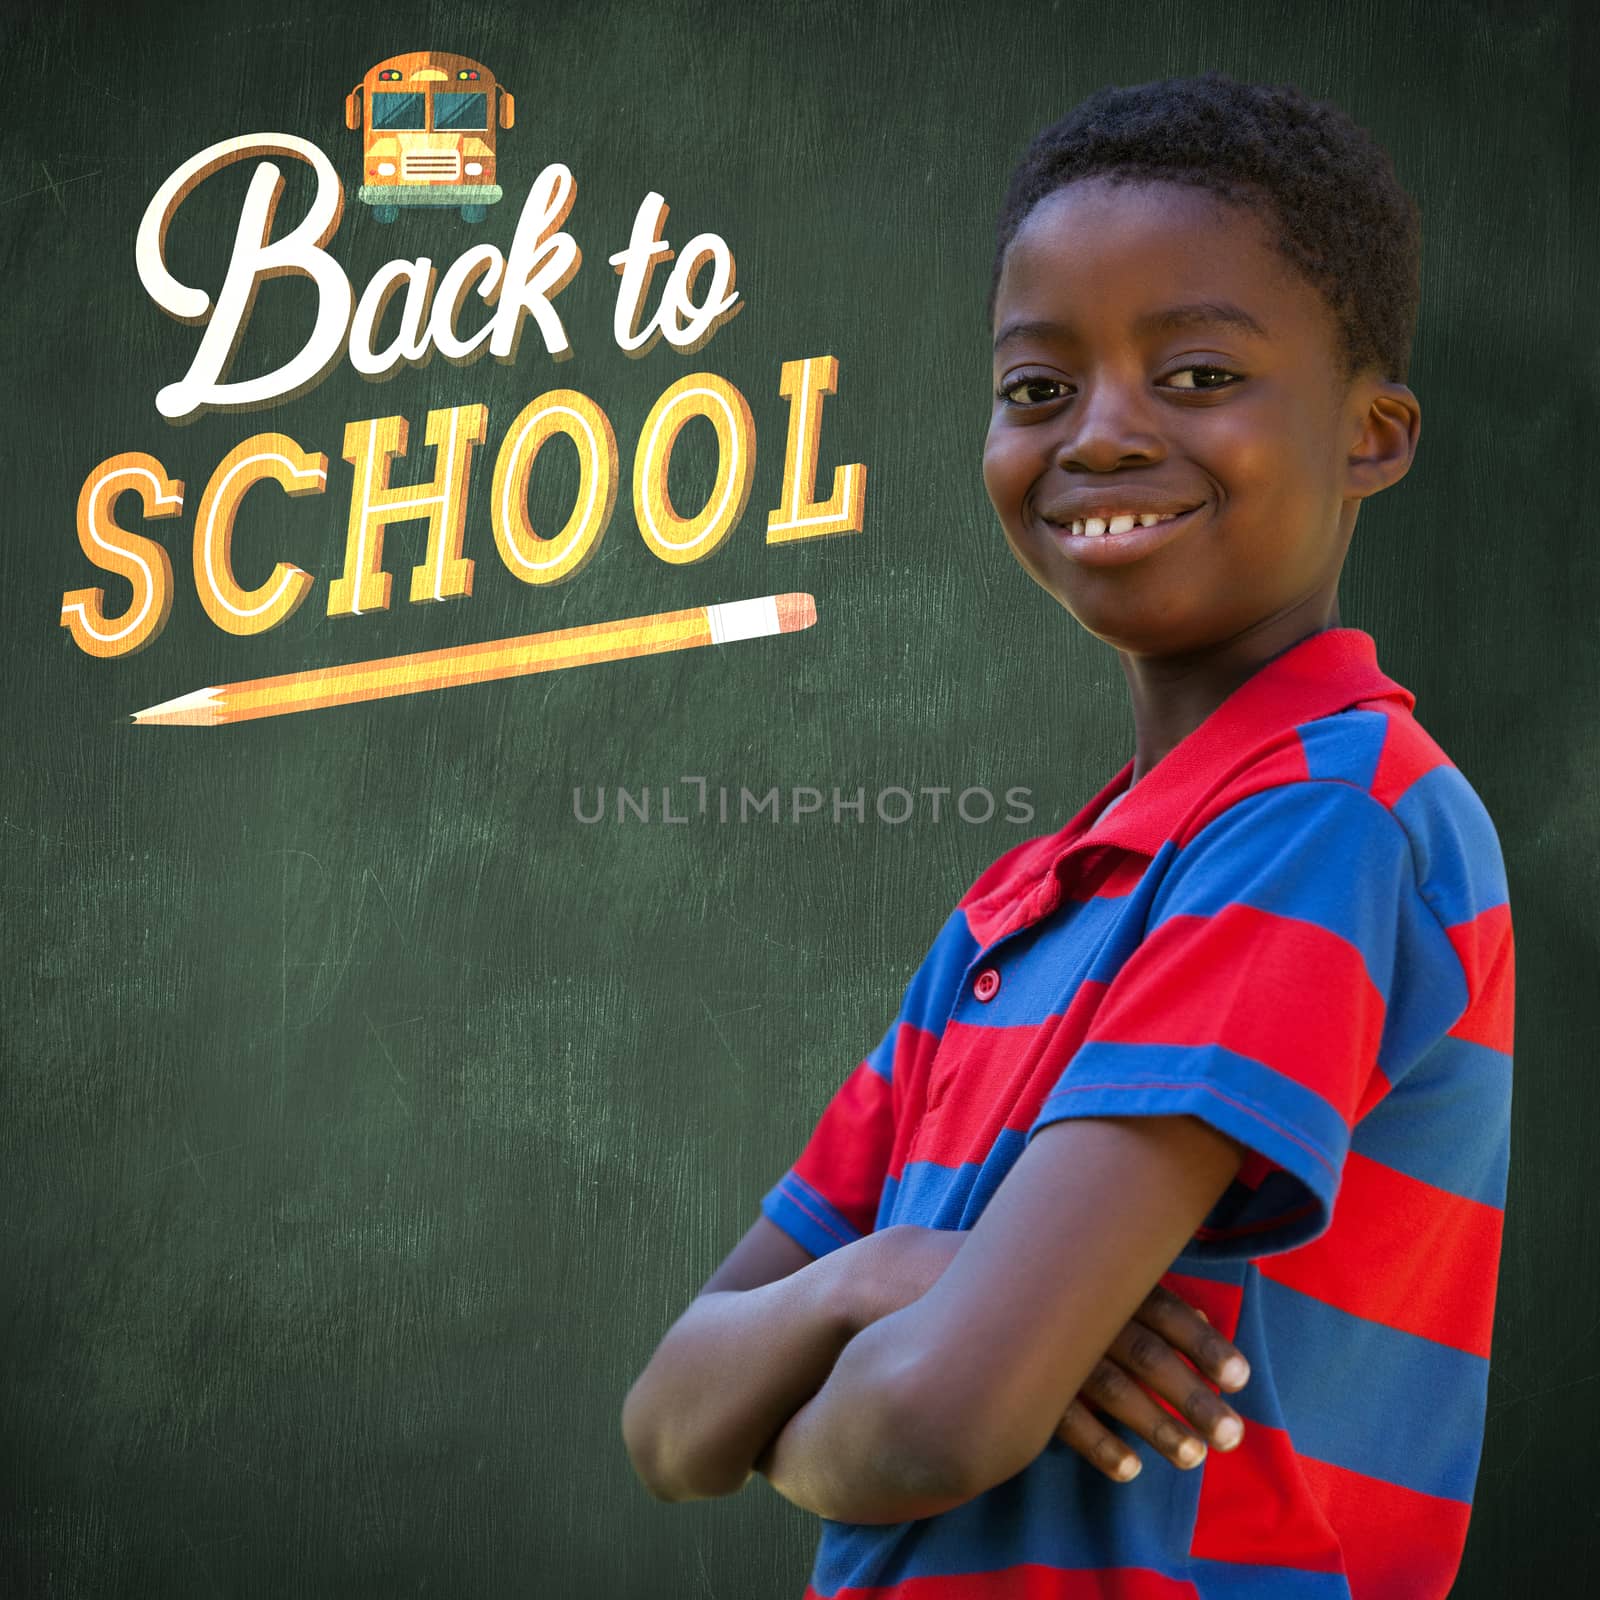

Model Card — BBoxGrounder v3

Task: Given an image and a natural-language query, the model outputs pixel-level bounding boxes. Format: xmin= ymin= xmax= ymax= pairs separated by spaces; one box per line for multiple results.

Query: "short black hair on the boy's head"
xmin=989 ymin=72 xmax=1422 ymax=382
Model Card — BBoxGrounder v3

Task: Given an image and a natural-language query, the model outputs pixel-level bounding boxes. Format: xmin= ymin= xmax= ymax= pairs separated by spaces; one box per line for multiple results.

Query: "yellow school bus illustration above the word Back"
xmin=344 ymin=50 xmax=517 ymax=222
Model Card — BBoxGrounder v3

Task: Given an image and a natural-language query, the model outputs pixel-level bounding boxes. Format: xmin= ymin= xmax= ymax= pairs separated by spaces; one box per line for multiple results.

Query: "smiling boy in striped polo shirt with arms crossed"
xmin=624 ymin=75 xmax=1514 ymax=1600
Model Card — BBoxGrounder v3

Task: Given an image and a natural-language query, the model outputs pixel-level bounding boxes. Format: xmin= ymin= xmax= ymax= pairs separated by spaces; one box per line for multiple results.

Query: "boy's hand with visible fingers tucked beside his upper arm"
xmin=1056 ymin=1286 xmax=1250 ymax=1483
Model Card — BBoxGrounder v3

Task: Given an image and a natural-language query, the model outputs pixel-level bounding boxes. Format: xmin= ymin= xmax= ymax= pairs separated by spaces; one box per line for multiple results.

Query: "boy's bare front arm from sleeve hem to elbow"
xmin=757 ymin=1117 xmax=1245 ymax=1523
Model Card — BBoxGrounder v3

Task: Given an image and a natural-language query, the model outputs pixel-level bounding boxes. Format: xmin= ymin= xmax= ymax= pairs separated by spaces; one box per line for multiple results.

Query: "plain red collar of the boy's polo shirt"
xmin=1056 ymin=627 xmax=1416 ymax=864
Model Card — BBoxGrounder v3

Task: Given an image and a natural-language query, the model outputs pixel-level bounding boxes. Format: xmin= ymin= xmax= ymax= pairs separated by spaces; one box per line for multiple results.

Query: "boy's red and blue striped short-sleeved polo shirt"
xmin=762 ymin=627 xmax=1514 ymax=1600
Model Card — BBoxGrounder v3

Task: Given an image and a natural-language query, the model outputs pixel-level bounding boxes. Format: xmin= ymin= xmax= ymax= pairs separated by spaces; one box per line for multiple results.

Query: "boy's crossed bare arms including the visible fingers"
xmin=622 ymin=1117 xmax=1245 ymax=1523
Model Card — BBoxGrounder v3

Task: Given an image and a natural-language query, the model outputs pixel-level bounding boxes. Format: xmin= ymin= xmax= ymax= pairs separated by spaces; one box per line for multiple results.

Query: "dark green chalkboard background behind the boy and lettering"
xmin=0 ymin=0 xmax=1600 ymax=1600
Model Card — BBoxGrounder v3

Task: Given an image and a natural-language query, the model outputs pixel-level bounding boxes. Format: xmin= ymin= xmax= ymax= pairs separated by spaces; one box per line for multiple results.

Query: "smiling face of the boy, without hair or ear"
xmin=984 ymin=178 xmax=1376 ymax=656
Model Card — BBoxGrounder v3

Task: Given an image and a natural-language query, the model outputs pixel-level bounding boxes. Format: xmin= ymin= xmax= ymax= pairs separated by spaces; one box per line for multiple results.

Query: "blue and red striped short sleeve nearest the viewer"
xmin=1029 ymin=779 xmax=1467 ymax=1258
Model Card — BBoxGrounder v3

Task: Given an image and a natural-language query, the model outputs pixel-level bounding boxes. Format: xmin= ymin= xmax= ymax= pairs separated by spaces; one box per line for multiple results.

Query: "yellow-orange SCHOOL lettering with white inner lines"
xmin=61 ymin=355 xmax=867 ymax=656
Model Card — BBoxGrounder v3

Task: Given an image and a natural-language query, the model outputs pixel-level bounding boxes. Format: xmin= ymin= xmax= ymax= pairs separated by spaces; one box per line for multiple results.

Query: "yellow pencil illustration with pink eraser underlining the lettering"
xmin=133 ymin=594 xmax=816 ymax=726
